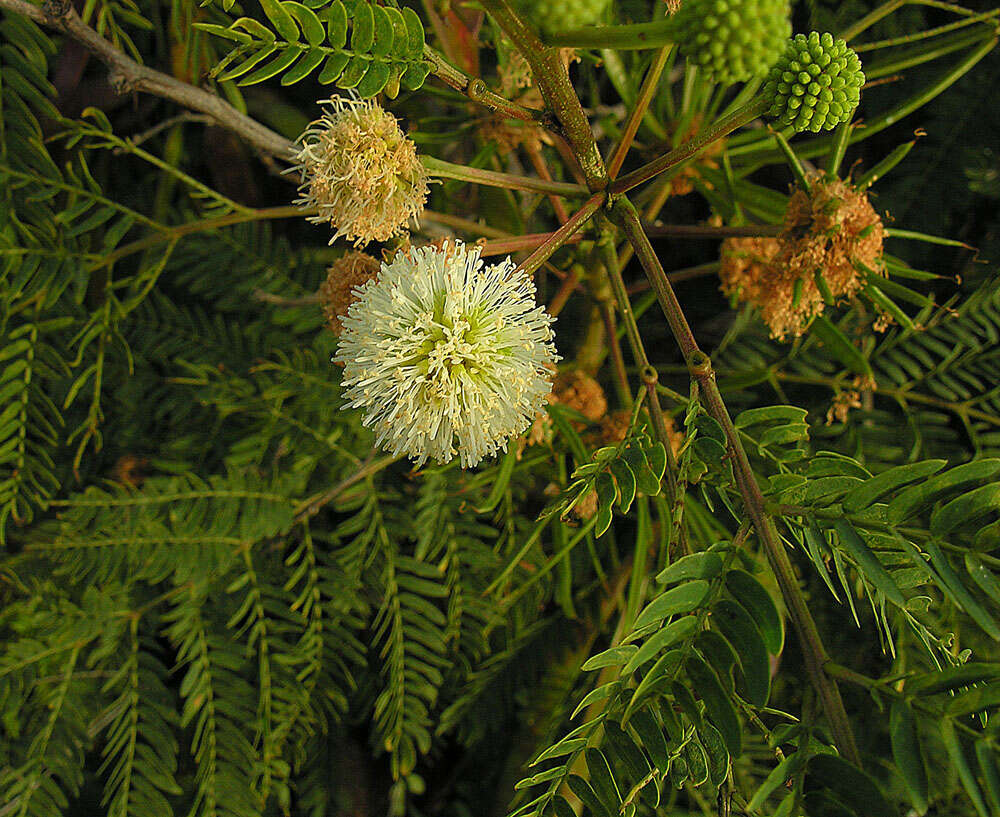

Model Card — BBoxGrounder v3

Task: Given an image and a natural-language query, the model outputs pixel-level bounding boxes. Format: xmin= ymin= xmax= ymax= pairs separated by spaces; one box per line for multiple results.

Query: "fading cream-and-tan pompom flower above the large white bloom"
xmin=293 ymin=97 xmax=427 ymax=247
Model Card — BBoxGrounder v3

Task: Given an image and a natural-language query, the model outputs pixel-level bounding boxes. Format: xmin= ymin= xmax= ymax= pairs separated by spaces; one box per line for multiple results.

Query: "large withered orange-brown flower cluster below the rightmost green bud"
xmin=719 ymin=176 xmax=884 ymax=339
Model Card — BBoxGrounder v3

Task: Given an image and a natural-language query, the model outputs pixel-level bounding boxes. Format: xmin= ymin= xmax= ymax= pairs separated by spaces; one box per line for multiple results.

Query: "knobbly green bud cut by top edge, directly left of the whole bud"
xmin=672 ymin=0 xmax=792 ymax=84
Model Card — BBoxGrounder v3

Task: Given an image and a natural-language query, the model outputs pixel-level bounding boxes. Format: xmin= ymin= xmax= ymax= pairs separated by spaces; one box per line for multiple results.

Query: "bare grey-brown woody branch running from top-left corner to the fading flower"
xmin=0 ymin=0 xmax=293 ymax=159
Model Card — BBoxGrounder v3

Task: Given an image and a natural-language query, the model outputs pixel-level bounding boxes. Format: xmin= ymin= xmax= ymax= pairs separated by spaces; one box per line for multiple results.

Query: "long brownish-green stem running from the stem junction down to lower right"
xmin=611 ymin=198 xmax=859 ymax=764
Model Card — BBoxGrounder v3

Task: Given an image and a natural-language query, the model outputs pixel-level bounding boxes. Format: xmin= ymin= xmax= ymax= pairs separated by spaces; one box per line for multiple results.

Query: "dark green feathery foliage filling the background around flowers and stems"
xmin=0 ymin=0 xmax=1000 ymax=817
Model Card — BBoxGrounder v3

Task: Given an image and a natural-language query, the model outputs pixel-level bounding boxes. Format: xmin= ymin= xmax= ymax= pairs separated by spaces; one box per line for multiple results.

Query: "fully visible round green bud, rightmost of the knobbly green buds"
xmin=763 ymin=31 xmax=865 ymax=133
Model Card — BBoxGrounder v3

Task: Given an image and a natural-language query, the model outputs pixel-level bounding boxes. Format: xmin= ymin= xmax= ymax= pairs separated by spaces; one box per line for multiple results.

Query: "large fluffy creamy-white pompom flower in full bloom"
xmin=334 ymin=237 xmax=558 ymax=468
